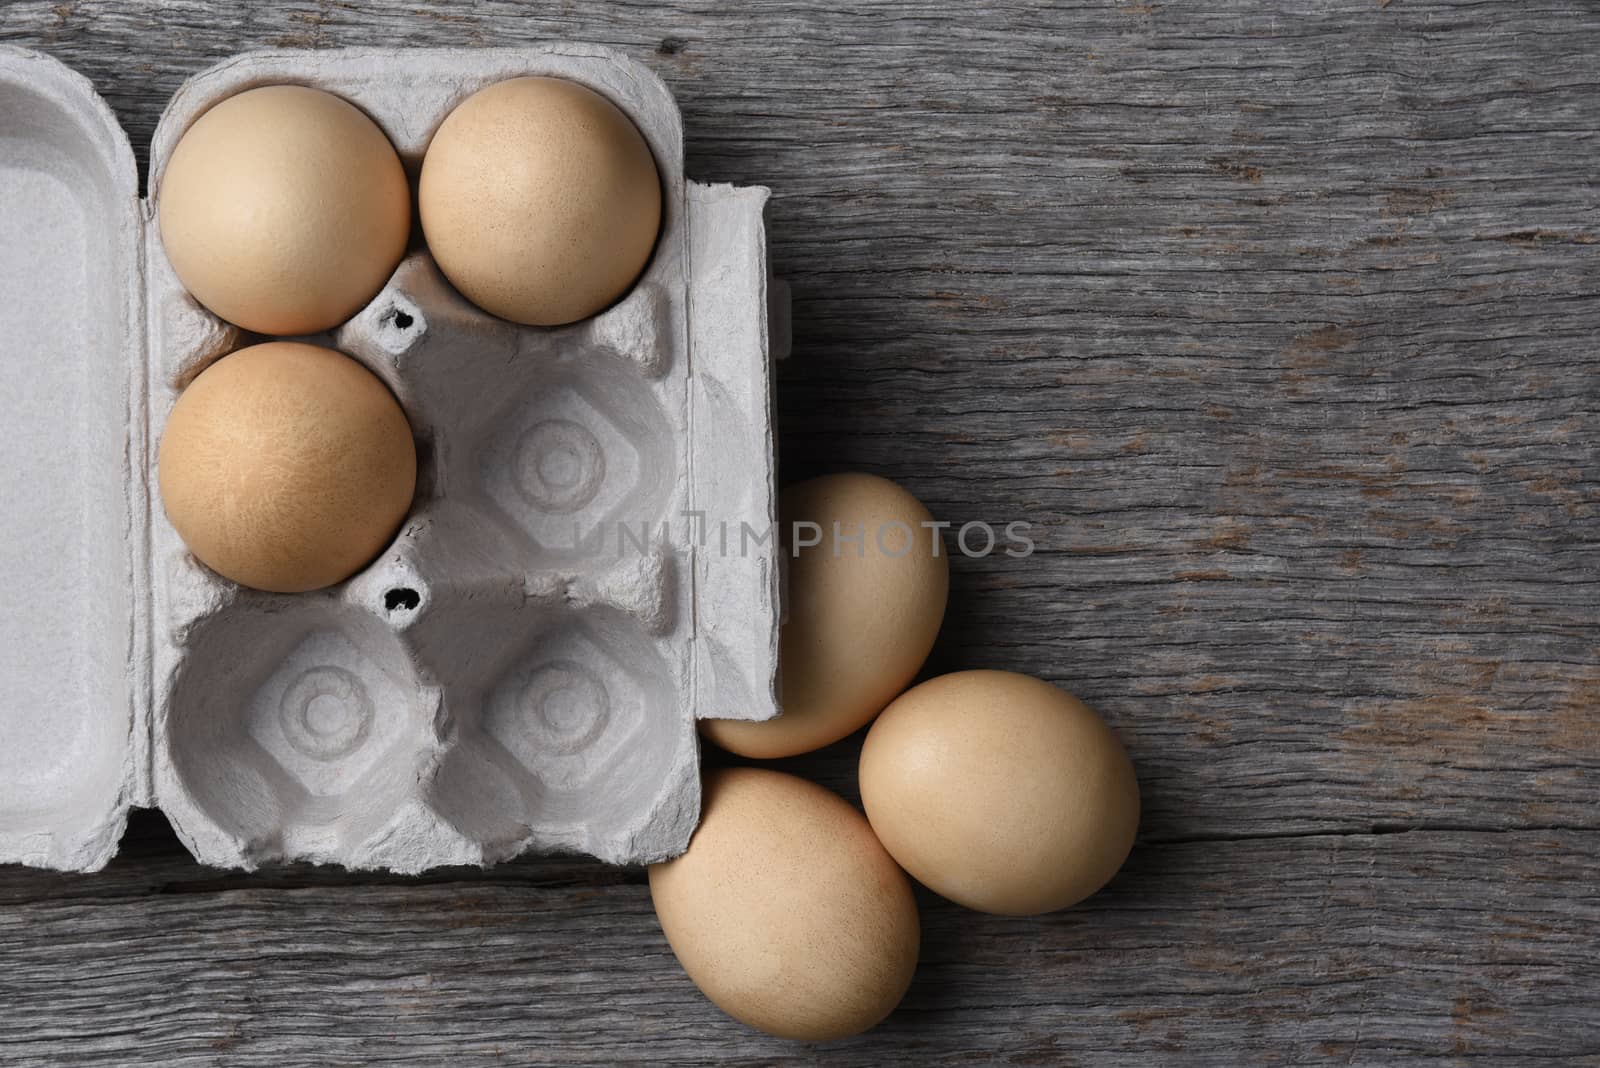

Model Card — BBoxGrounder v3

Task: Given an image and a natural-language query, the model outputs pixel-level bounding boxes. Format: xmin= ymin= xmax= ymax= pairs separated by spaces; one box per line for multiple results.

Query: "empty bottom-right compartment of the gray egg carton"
xmin=412 ymin=598 xmax=698 ymax=860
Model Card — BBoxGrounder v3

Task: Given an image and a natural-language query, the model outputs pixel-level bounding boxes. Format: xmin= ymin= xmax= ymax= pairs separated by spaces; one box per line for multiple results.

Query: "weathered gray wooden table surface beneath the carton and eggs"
xmin=0 ymin=0 xmax=1600 ymax=1065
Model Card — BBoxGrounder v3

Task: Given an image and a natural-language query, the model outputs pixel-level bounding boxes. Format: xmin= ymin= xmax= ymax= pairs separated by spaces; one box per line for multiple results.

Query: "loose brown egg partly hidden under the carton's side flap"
xmin=701 ymin=473 xmax=950 ymax=758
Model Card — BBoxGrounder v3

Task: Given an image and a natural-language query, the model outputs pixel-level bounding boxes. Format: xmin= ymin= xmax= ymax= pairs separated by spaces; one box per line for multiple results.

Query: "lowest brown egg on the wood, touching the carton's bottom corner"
xmin=650 ymin=767 xmax=920 ymax=1041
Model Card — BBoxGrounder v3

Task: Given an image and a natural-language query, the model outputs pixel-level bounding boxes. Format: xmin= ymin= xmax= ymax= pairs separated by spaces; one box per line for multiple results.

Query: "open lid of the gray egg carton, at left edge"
xmin=0 ymin=46 xmax=149 ymax=870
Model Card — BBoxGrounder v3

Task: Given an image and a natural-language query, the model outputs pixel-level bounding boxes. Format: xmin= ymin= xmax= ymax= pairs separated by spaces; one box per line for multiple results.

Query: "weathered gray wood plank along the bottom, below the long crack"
xmin=0 ymin=812 xmax=1600 ymax=1066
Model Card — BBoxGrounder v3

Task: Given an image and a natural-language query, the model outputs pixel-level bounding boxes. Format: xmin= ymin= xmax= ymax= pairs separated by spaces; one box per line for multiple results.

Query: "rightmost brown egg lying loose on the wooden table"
xmin=861 ymin=671 xmax=1139 ymax=916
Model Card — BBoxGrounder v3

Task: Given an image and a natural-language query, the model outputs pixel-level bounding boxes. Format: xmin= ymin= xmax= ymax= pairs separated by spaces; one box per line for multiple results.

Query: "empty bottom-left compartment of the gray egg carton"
xmin=162 ymin=596 xmax=440 ymax=865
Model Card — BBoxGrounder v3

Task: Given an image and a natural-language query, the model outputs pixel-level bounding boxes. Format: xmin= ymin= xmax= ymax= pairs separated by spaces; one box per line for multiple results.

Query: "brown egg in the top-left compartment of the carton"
xmin=157 ymin=85 xmax=411 ymax=334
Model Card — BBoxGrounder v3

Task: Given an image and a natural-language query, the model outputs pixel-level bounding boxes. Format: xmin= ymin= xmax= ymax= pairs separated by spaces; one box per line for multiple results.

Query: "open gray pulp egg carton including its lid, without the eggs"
xmin=0 ymin=45 xmax=787 ymax=871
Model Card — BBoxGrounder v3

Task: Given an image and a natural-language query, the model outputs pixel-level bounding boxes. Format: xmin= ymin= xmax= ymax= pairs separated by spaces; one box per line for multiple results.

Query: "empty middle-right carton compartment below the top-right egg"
xmin=336 ymin=253 xmax=688 ymax=571
